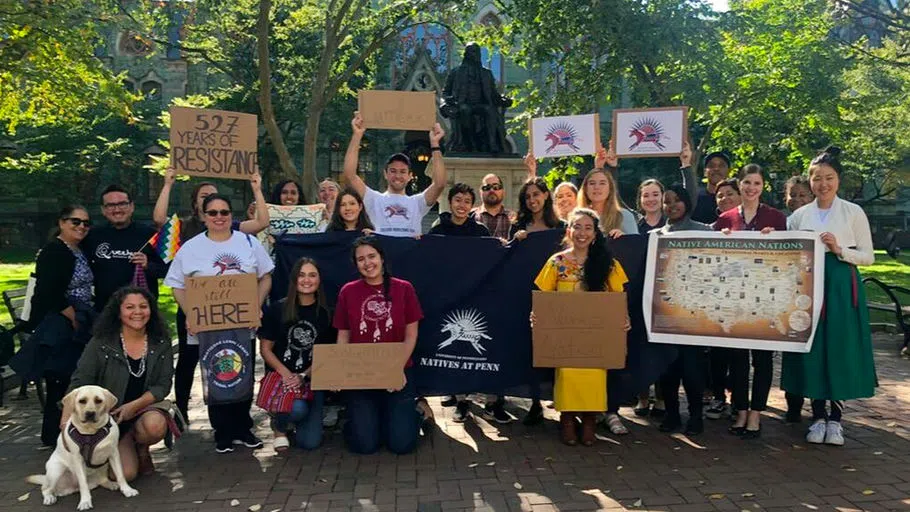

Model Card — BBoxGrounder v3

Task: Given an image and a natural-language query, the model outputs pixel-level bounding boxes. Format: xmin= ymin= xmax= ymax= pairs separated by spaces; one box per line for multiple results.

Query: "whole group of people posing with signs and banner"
xmin=17 ymin=110 xmax=875 ymax=478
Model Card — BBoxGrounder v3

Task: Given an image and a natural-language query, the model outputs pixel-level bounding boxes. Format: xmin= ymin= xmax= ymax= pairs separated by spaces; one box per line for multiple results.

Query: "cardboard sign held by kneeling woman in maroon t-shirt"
xmin=311 ymin=343 xmax=404 ymax=390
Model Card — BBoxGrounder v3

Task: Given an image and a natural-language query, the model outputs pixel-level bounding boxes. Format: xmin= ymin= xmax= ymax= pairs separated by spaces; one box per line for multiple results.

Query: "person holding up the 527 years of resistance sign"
xmin=152 ymin=167 xmax=269 ymax=419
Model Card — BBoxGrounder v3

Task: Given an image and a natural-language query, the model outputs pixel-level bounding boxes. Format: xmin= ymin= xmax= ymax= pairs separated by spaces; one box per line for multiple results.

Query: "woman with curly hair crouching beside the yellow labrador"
xmin=60 ymin=287 xmax=176 ymax=480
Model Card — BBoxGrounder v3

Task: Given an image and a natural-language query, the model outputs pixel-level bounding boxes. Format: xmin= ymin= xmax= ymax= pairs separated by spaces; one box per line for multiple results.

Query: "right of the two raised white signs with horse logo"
xmin=613 ymin=107 xmax=689 ymax=158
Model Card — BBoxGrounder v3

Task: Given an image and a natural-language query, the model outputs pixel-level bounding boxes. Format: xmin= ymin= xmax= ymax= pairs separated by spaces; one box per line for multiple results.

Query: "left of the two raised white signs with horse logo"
xmin=528 ymin=114 xmax=600 ymax=158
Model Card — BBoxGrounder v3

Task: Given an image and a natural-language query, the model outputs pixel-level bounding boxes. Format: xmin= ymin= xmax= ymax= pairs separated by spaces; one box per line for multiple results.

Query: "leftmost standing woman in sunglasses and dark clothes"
xmin=17 ymin=206 xmax=94 ymax=446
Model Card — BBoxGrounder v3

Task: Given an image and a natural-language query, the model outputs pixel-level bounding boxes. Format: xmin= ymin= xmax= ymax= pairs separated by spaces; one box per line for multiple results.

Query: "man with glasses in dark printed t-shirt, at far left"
xmin=82 ymin=185 xmax=167 ymax=311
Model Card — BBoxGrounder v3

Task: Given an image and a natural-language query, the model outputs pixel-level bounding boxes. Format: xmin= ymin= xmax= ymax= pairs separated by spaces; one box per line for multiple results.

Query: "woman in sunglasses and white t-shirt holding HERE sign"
xmin=164 ymin=194 xmax=275 ymax=453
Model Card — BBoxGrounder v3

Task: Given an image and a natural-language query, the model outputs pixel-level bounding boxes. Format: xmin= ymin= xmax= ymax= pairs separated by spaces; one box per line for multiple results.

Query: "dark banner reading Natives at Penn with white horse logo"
xmin=272 ymin=230 xmax=675 ymax=400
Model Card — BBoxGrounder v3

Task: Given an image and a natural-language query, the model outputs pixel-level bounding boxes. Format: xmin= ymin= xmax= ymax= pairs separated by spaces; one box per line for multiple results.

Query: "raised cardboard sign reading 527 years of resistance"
xmin=170 ymin=107 xmax=259 ymax=180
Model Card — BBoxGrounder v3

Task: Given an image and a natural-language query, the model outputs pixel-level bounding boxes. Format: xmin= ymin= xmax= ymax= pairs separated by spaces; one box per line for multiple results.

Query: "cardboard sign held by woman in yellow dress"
xmin=532 ymin=291 xmax=628 ymax=369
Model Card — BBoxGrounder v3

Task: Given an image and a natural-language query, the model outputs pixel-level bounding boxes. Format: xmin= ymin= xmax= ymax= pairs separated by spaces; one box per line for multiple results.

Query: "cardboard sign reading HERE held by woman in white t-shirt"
xmin=186 ymin=274 xmax=260 ymax=332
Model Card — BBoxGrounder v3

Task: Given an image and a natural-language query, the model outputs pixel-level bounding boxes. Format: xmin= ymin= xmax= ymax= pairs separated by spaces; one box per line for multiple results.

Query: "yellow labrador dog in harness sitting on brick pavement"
xmin=27 ymin=386 xmax=139 ymax=510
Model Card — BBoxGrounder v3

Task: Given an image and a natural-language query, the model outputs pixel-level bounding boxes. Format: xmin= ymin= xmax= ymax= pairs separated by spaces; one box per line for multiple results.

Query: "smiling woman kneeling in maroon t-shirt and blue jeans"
xmin=334 ymin=237 xmax=423 ymax=454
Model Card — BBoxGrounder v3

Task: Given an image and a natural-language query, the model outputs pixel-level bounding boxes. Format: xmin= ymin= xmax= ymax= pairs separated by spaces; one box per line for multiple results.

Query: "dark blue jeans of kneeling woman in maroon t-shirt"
xmin=343 ymin=370 xmax=420 ymax=455
